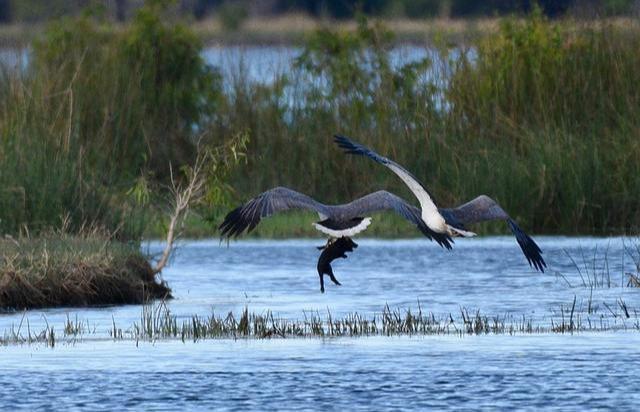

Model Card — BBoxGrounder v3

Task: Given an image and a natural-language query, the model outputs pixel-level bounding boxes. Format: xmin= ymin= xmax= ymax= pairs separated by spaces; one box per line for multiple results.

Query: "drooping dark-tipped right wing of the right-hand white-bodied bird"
xmin=440 ymin=195 xmax=547 ymax=272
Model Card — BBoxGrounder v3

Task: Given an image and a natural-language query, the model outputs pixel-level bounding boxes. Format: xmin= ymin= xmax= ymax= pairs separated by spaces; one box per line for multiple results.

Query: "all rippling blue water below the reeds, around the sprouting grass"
xmin=0 ymin=237 xmax=640 ymax=410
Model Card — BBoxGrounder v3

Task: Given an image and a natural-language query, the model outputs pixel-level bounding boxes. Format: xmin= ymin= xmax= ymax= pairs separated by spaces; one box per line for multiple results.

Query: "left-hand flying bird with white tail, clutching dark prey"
xmin=219 ymin=187 xmax=453 ymax=292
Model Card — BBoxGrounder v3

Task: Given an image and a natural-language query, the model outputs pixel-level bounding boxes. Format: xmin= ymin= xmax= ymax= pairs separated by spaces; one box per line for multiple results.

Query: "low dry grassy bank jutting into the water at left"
xmin=0 ymin=231 xmax=171 ymax=310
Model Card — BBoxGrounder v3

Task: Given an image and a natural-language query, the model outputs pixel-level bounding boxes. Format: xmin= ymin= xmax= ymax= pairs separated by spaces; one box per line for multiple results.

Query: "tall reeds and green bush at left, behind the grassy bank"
xmin=0 ymin=6 xmax=225 ymax=239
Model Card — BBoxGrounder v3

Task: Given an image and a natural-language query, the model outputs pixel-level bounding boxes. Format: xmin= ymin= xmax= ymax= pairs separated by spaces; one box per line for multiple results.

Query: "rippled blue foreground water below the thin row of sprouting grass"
xmin=0 ymin=333 xmax=640 ymax=411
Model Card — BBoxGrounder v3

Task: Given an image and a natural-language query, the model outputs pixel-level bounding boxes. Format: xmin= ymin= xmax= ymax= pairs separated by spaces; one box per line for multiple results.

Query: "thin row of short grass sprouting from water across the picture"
xmin=0 ymin=297 xmax=640 ymax=347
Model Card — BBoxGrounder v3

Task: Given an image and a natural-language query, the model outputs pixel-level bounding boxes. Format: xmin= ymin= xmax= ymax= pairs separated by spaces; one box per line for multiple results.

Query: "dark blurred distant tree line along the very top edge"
xmin=0 ymin=0 xmax=640 ymax=23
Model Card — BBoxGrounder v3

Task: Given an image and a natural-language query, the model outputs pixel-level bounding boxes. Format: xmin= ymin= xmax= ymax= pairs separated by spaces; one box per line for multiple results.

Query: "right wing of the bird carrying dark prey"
xmin=343 ymin=190 xmax=453 ymax=249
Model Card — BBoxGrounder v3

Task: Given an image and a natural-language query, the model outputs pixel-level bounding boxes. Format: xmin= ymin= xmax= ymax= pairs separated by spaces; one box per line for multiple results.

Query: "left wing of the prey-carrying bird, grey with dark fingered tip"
xmin=219 ymin=187 xmax=328 ymax=238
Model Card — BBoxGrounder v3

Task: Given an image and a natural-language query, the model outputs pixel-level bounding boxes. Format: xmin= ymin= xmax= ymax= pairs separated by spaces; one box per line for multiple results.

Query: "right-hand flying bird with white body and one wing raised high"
xmin=334 ymin=135 xmax=547 ymax=272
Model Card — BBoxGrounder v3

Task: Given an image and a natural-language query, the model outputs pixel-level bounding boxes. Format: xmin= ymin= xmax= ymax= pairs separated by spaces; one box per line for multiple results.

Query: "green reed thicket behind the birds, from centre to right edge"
xmin=216 ymin=12 xmax=640 ymax=234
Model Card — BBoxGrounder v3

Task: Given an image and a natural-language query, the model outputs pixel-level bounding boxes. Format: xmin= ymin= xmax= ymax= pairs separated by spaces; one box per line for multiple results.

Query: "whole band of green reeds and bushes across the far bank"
xmin=0 ymin=2 xmax=640 ymax=239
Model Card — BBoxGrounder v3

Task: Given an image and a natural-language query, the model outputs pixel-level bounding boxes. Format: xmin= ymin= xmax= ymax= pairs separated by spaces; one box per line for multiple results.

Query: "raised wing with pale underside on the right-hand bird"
xmin=333 ymin=135 xmax=438 ymax=229
